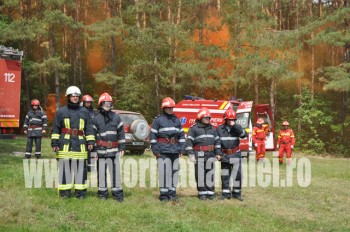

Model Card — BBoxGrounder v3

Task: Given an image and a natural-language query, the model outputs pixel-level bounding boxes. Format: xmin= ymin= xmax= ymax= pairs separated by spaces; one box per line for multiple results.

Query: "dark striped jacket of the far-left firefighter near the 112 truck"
xmin=23 ymin=110 xmax=47 ymax=137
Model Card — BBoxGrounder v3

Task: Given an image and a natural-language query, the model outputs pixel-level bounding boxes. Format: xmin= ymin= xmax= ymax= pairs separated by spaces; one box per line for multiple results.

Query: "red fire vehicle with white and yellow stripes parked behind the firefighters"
xmin=174 ymin=97 xmax=276 ymax=157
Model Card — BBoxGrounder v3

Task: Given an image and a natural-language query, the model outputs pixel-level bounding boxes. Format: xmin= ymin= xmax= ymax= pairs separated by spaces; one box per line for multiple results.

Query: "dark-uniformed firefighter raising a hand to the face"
xmin=216 ymin=108 xmax=247 ymax=201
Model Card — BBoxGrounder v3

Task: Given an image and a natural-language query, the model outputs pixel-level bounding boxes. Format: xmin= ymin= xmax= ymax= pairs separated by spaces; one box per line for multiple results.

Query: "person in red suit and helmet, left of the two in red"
xmin=252 ymin=118 xmax=266 ymax=161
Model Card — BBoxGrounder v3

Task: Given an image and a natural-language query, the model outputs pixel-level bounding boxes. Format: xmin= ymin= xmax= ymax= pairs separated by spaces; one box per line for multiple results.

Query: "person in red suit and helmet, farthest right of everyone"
xmin=277 ymin=121 xmax=295 ymax=164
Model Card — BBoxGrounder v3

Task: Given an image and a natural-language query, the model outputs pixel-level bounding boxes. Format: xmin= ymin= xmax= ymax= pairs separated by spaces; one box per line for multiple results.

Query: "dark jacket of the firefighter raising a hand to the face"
xmin=216 ymin=123 xmax=247 ymax=162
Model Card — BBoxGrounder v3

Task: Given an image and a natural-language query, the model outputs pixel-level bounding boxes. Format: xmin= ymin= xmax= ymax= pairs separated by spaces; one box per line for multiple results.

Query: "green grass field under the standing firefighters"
xmin=0 ymin=138 xmax=350 ymax=231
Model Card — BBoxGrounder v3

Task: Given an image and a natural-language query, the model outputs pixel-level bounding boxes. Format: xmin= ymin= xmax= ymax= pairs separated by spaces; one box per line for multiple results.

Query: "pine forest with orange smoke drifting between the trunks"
xmin=0 ymin=0 xmax=350 ymax=157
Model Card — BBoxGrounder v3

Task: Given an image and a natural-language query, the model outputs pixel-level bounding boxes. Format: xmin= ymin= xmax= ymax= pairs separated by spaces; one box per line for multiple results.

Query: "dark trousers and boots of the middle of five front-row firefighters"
xmin=157 ymin=153 xmax=180 ymax=201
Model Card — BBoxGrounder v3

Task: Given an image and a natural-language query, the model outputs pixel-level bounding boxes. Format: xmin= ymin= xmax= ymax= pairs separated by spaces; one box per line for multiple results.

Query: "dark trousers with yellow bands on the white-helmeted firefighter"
xmin=58 ymin=159 xmax=87 ymax=198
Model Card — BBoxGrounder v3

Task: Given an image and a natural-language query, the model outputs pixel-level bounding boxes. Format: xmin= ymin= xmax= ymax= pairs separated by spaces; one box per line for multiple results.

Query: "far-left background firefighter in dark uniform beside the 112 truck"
xmin=23 ymin=99 xmax=47 ymax=159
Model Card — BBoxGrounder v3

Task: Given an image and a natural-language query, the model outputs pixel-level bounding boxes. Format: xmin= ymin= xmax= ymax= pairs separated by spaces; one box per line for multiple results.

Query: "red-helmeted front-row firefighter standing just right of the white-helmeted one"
xmin=92 ymin=93 xmax=125 ymax=202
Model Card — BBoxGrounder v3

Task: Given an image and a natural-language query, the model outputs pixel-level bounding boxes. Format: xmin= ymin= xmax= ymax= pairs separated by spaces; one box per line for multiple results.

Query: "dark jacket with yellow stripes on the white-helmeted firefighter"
xmin=51 ymin=105 xmax=95 ymax=159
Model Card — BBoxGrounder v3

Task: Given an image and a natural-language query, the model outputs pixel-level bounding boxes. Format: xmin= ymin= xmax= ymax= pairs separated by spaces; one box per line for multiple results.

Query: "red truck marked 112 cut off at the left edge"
xmin=0 ymin=45 xmax=23 ymax=138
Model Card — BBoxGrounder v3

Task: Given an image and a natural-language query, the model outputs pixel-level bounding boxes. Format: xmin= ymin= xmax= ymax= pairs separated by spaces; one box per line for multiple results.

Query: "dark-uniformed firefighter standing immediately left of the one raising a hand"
xmin=186 ymin=107 xmax=222 ymax=200
